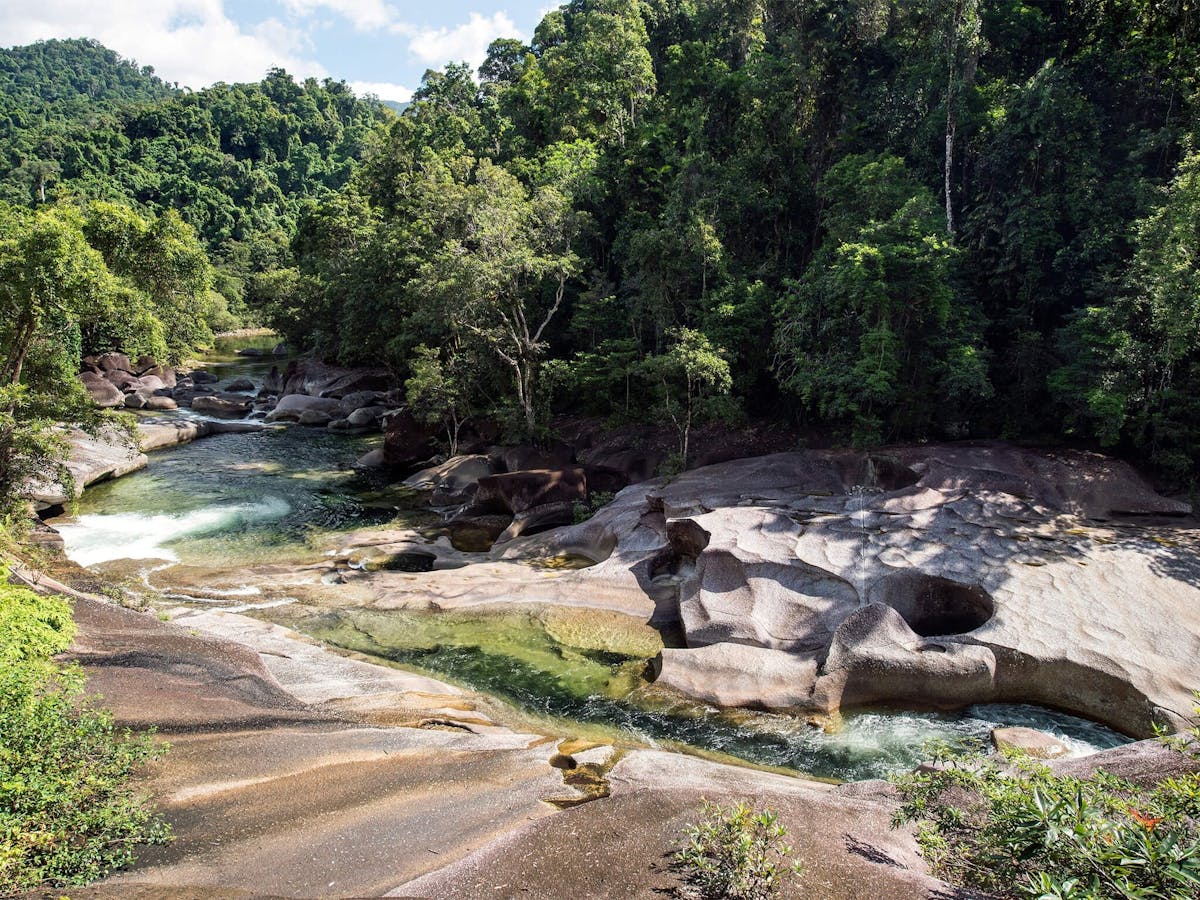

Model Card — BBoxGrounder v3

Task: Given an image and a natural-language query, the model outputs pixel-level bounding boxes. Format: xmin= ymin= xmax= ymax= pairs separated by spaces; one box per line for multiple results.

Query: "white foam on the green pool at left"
xmin=58 ymin=496 xmax=292 ymax=566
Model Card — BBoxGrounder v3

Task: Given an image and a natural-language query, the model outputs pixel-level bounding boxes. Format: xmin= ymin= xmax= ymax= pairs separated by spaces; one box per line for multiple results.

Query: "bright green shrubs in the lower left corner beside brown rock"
xmin=0 ymin=568 xmax=167 ymax=896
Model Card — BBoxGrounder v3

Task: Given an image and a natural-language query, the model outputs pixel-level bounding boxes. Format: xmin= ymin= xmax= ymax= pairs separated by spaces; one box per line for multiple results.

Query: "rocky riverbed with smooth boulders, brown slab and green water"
xmin=32 ymin=340 xmax=1200 ymax=898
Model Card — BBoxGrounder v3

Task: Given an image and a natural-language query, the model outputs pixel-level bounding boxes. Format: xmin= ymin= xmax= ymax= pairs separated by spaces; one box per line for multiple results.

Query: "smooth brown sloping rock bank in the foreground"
xmin=11 ymin=561 xmax=946 ymax=898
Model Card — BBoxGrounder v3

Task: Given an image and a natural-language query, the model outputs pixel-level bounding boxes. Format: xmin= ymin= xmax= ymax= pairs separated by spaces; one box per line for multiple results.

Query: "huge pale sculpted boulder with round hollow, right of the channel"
xmin=444 ymin=444 xmax=1200 ymax=736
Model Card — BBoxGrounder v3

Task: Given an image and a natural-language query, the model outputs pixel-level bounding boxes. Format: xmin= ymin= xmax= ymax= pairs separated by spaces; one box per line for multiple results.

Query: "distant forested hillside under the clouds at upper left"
xmin=0 ymin=40 xmax=392 ymax=316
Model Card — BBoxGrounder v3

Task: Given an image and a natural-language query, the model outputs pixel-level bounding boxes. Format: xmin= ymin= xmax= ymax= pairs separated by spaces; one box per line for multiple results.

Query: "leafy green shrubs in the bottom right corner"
xmin=896 ymin=743 xmax=1200 ymax=900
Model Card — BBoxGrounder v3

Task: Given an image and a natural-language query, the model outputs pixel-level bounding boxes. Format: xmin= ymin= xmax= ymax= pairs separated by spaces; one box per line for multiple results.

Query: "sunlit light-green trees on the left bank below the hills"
xmin=0 ymin=202 xmax=225 ymax=523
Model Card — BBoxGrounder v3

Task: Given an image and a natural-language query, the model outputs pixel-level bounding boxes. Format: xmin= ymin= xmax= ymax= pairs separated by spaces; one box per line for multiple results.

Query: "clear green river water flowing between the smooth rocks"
xmin=54 ymin=338 xmax=1127 ymax=779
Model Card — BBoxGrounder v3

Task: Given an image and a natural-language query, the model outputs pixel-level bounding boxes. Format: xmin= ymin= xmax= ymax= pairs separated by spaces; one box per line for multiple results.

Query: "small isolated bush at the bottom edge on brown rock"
xmin=674 ymin=800 xmax=803 ymax=900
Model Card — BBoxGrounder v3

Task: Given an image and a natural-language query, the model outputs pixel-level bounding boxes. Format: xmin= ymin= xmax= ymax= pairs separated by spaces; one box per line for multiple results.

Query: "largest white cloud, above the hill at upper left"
xmin=0 ymin=0 xmax=326 ymax=88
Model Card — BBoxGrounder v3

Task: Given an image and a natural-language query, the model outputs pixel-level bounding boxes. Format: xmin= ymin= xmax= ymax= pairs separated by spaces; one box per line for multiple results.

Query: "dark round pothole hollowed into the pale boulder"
xmin=871 ymin=572 xmax=996 ymax=637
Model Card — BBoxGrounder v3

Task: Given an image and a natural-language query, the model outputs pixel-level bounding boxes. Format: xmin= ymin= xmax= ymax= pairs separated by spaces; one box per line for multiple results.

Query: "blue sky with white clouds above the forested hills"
xmin=0 ymin=0 xmax=558 ymax=102
